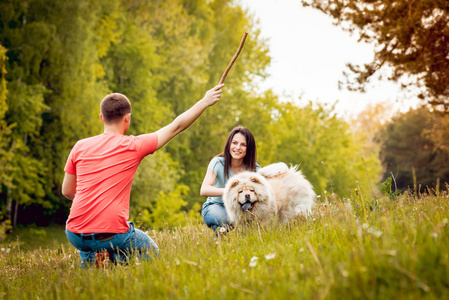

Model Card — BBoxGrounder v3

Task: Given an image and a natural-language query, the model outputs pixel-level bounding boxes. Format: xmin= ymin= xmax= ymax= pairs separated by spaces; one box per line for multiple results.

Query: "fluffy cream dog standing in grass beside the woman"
xmin=223 ymin=163 xmax=315 ymax=225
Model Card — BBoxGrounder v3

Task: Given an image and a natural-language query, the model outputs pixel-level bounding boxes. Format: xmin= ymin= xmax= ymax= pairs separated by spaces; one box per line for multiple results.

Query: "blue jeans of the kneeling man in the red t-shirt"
xmin=65 ymin=222 xmax=159 ymax=267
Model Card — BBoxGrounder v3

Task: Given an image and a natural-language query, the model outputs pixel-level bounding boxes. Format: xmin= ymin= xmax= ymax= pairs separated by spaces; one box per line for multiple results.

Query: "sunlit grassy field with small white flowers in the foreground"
xmin=0 ymin=193 xmax=449 ymax=300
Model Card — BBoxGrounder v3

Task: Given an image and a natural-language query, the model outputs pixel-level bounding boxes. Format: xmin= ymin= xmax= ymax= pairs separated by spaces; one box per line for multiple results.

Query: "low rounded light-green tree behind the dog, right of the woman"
xmin=262 ymin=102 xmax=381 ymax=196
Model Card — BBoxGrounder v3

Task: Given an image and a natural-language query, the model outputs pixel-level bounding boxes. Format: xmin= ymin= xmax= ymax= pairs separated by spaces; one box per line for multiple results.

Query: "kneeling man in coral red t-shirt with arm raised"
xmin=62 ymin=84 xmax=224 ymax=266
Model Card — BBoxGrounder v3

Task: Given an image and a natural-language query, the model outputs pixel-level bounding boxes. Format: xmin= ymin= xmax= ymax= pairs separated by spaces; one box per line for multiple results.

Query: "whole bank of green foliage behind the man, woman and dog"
xmin=0 ymin=0 xmax=380 ymax=228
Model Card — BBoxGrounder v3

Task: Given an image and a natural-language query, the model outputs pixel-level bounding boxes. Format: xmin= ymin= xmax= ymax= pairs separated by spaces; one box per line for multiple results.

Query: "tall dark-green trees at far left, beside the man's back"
xmin=0 ymin=0 xmax=118 ymax=225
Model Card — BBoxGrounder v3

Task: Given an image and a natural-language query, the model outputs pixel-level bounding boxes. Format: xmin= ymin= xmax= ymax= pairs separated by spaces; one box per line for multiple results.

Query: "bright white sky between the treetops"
xmin=239 ymin=0 xmax=418 ymax=116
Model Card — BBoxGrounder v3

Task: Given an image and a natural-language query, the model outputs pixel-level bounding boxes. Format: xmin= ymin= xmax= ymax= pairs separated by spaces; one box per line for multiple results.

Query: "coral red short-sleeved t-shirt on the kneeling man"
xmin=64 ymin=133 xmax=157 ymax=233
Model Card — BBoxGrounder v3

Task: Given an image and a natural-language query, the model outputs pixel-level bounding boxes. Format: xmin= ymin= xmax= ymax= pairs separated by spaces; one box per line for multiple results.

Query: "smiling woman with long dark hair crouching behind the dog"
xmin=200 ymin=126 xmax=260 ymax=231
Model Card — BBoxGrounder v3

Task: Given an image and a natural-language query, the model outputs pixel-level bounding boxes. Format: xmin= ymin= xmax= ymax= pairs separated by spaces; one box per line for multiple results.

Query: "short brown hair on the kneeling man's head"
xmin=100 ymin=93 xmax=131 ymax=124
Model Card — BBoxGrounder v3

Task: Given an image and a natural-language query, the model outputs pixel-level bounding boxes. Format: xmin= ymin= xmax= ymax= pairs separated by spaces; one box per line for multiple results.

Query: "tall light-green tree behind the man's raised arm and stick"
xmin=112 ymin=0 xmax=269 ymax=213
